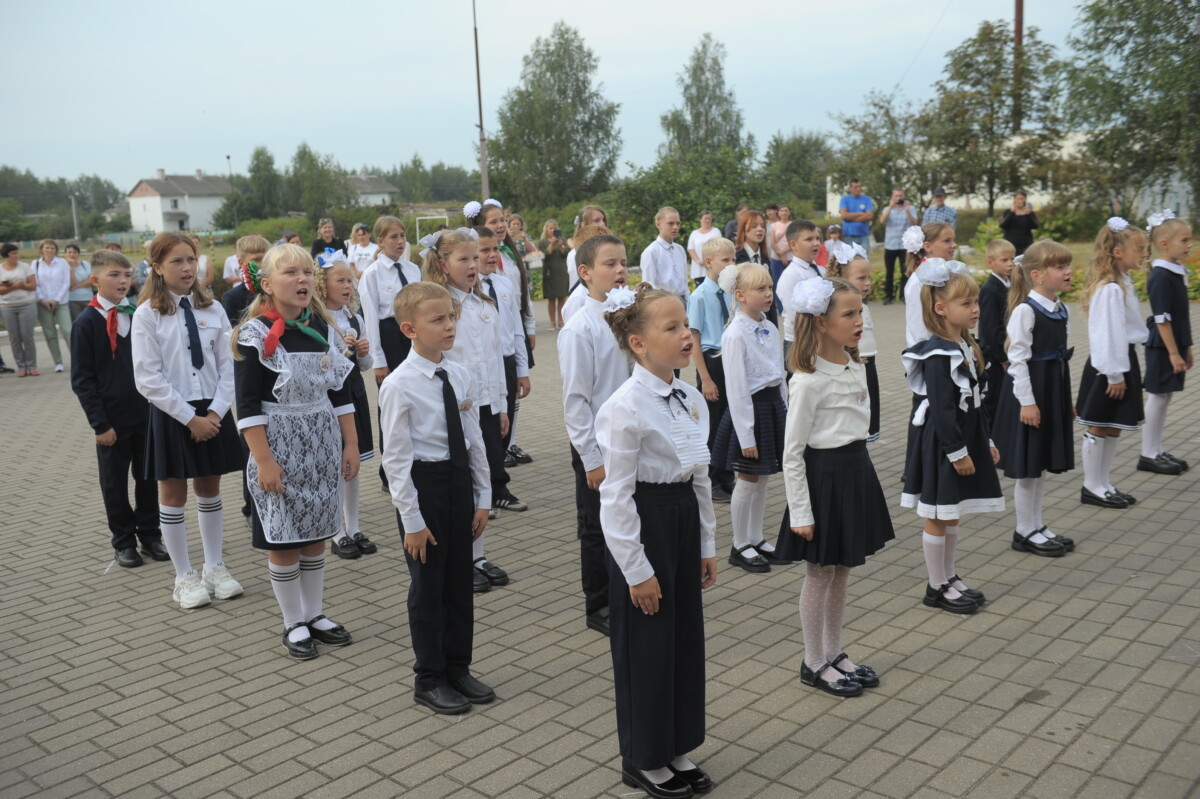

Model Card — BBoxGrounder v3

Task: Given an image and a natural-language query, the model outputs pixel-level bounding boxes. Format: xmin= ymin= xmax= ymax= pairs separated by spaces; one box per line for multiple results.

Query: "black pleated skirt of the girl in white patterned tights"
xmin=775 ymin=440 xmax=895 ymax=566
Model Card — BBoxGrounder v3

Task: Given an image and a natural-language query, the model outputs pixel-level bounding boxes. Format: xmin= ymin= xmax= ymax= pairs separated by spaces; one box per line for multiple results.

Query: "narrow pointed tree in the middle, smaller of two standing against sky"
xmin=659 ymin=34 xmax=755 ymax=158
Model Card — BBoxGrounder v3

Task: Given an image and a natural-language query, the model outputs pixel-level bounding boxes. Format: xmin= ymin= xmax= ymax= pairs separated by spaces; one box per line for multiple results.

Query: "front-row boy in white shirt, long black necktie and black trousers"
xmin=379 ymin=282 xmax=496 ymax=714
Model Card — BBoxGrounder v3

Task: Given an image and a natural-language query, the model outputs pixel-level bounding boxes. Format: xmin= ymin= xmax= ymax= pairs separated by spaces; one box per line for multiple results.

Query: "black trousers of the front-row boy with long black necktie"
xmin=396 ymin=461 xmax=475 ymax=691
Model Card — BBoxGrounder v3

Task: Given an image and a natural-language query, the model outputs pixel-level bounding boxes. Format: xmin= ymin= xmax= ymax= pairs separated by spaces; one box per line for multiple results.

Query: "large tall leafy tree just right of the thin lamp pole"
xmin=487 ymin=22 xmax=620 ymax=206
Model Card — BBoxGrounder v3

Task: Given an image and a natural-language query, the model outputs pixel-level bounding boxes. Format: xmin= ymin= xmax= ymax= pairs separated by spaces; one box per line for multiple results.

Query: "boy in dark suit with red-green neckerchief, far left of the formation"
xmin=71 ymin=250 xmax=170 ymax=569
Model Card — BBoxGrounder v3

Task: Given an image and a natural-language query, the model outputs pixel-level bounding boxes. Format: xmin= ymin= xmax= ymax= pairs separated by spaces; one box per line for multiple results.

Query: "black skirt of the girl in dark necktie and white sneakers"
xmin=143 ymin=400 xmax=246 ymax=480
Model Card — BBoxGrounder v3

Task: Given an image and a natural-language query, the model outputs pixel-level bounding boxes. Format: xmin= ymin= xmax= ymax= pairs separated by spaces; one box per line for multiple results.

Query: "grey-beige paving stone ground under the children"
xmin=0 ymin=304 xmax=1200 ymax=799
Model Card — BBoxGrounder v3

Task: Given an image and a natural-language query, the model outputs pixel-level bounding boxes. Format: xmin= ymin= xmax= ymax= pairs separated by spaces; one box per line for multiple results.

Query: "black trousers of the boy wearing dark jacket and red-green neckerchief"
xmin=96 ymin=426 xmax=162 ymax=549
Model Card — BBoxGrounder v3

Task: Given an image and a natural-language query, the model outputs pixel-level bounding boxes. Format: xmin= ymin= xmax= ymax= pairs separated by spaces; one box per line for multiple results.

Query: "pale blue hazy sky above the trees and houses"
xmin=0 ymin=0 xmax=1076 ymax=190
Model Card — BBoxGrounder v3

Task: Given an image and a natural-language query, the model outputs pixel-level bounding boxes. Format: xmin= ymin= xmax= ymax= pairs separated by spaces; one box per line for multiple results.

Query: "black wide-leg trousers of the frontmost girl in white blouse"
xmin=607 ymin=481 xmax=704 ymax=769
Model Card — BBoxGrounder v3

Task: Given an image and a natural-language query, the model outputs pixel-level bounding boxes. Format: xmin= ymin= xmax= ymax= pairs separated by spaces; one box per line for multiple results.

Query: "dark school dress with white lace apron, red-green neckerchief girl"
xmin=234 ymin=317 xmax=354 ymax=549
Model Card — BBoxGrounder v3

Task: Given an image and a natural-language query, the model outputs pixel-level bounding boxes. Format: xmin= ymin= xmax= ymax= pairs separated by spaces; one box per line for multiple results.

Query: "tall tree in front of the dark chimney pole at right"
xmin=925 ymin=20 xmax=1061 ymax=216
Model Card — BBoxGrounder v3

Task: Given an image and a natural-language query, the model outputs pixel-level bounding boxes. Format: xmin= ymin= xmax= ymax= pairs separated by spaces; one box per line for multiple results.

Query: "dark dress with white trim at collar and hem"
xmin=900 ymin=336 xmax=1004 ymax=519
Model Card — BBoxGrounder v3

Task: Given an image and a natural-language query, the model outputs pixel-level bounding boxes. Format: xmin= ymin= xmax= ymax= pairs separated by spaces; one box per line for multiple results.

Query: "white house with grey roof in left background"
xmin=130 ymin=169 xmax=233 ymax=233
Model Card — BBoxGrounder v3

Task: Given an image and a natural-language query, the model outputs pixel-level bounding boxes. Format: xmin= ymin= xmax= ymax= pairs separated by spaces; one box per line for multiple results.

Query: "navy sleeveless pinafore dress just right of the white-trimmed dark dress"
xmin=991 ymin=299 xmax=1075 ymax=480
